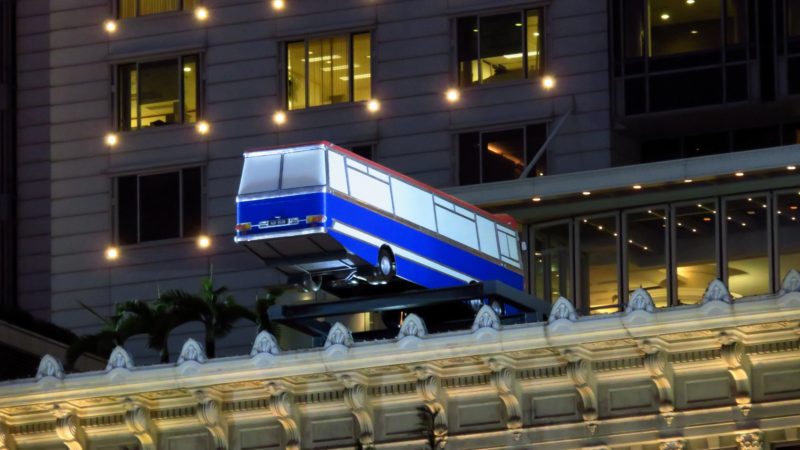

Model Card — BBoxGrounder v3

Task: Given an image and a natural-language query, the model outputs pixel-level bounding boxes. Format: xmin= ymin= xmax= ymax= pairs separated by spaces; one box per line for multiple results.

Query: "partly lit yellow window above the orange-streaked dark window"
xmin=457 ymin=9 xmax=544 ymax=86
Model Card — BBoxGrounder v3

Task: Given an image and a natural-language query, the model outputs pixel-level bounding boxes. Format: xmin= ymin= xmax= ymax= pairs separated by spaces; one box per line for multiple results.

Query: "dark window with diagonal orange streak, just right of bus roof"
xmin=458 ymin=124 xmax=547 ymax=185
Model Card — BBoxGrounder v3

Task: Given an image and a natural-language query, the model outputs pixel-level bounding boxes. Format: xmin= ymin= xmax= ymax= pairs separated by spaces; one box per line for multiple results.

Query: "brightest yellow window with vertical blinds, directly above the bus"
xmin=286 ymin=33 xmax=372 ymax=110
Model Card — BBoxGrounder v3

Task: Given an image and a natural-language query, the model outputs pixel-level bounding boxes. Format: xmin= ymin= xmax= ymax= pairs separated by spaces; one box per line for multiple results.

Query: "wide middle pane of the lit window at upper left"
xmin=139 ymin=59 xmax=180 ymax=127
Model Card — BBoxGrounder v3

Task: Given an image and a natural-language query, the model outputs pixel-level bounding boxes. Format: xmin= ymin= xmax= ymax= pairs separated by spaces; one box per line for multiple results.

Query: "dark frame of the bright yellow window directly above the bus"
xmin=278 ymin=28 xmax=375 ymax=113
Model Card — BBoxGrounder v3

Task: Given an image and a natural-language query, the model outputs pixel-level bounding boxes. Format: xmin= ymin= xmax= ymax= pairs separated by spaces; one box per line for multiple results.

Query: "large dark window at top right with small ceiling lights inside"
xmin=613 ymin=0 xmax=755 ymax=115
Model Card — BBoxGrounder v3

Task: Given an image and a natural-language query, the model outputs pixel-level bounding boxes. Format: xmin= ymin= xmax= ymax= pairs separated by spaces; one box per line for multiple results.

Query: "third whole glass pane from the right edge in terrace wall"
xmin=623 ymin=208 xmax=669 ymax=307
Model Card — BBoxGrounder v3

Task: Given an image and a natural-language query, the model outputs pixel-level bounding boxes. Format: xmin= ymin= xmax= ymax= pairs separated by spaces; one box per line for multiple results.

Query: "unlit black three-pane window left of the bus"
xmin=116 ymin=168 xmax=203 ymax=245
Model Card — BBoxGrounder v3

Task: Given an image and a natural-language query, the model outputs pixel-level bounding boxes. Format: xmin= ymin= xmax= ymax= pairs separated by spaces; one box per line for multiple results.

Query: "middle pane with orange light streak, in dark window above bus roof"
xmin=481 ymin=128 xmax=525 ymax=183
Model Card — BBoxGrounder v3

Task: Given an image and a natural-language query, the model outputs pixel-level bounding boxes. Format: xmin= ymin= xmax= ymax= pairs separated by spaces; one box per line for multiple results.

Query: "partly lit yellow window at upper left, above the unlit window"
xmin=118 ymin=56 xmax=199 ymax=130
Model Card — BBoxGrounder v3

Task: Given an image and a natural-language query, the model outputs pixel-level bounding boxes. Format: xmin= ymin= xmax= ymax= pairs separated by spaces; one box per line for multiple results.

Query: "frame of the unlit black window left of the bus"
xmin=110 ymin=165 xmax=207 ymax=247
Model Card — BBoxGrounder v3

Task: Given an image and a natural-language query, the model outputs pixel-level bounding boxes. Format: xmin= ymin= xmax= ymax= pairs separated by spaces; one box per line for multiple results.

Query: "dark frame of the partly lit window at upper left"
xmin=112 ymin=52 xmax=206 ymax=133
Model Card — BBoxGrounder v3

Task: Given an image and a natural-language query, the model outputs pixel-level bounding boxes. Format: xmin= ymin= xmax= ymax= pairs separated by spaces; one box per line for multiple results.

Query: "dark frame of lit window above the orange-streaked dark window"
xmin=450 ymin=5 xmax=550 ymax=89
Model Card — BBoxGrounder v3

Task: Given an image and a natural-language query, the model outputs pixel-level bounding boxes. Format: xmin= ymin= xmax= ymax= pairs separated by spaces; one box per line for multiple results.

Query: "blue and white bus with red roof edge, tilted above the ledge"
xmin=235 ymin=142 xmax=524 ymax=290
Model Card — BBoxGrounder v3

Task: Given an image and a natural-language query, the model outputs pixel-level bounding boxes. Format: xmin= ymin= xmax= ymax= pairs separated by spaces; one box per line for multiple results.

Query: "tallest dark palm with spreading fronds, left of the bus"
xmin=156 ymin=276 xmax=257 ymax=358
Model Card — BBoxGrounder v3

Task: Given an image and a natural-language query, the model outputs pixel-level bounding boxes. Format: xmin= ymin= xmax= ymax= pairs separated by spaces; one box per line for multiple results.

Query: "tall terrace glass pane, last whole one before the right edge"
xmin=725 ymin=196 xmax=771 ymax=298
